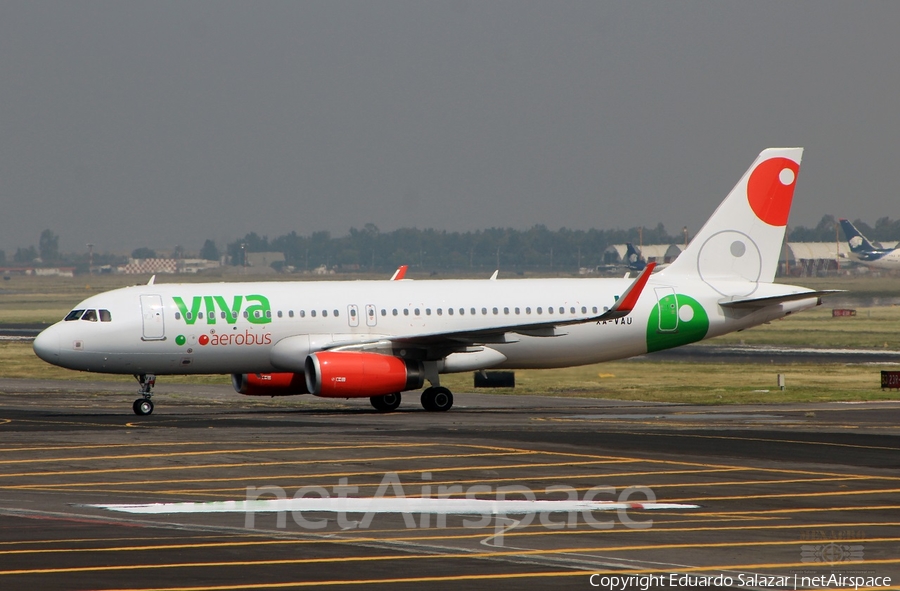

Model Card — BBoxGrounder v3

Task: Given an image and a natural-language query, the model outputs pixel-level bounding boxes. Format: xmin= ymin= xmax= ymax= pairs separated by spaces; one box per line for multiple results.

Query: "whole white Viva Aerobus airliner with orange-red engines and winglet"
xmin=34 ymin=148 xmax=831 ymax=415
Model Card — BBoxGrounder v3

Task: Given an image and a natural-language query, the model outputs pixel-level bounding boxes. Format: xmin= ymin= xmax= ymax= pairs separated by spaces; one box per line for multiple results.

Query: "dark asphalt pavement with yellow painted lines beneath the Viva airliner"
xmin=0 ymin=378 xmax=900 ymax=591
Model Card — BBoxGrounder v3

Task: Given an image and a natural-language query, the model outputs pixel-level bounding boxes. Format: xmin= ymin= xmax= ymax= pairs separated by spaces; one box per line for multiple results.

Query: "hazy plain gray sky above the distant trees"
xmin=0 ymin=0 xmax=900 ymax=256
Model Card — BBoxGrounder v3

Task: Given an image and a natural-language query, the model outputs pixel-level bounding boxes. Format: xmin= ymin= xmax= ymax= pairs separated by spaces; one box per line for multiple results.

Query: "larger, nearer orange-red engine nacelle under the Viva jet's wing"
xmin=306 ymin=351 xmax=425 ymax=398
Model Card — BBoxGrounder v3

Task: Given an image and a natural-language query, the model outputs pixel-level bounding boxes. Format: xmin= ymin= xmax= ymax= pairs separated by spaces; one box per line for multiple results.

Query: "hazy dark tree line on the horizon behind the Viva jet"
xmin=7 ymin=215 xmax=900 ymax=273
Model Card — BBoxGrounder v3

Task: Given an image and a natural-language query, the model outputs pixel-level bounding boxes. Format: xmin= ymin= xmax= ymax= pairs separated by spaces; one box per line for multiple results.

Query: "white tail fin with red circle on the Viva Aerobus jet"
xmin=662 ymin=148 xmax=803 ymax=295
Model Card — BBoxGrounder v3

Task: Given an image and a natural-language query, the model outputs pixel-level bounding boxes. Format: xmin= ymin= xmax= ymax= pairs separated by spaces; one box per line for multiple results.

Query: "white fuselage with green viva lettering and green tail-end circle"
xmin=35 ymin=274 xmax=817 ymax=374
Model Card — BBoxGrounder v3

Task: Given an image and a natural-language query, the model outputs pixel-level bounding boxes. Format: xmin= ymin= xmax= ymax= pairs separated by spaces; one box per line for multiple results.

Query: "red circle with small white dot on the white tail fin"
xmin=747 ymin=158 xmax=800 ymax=226
